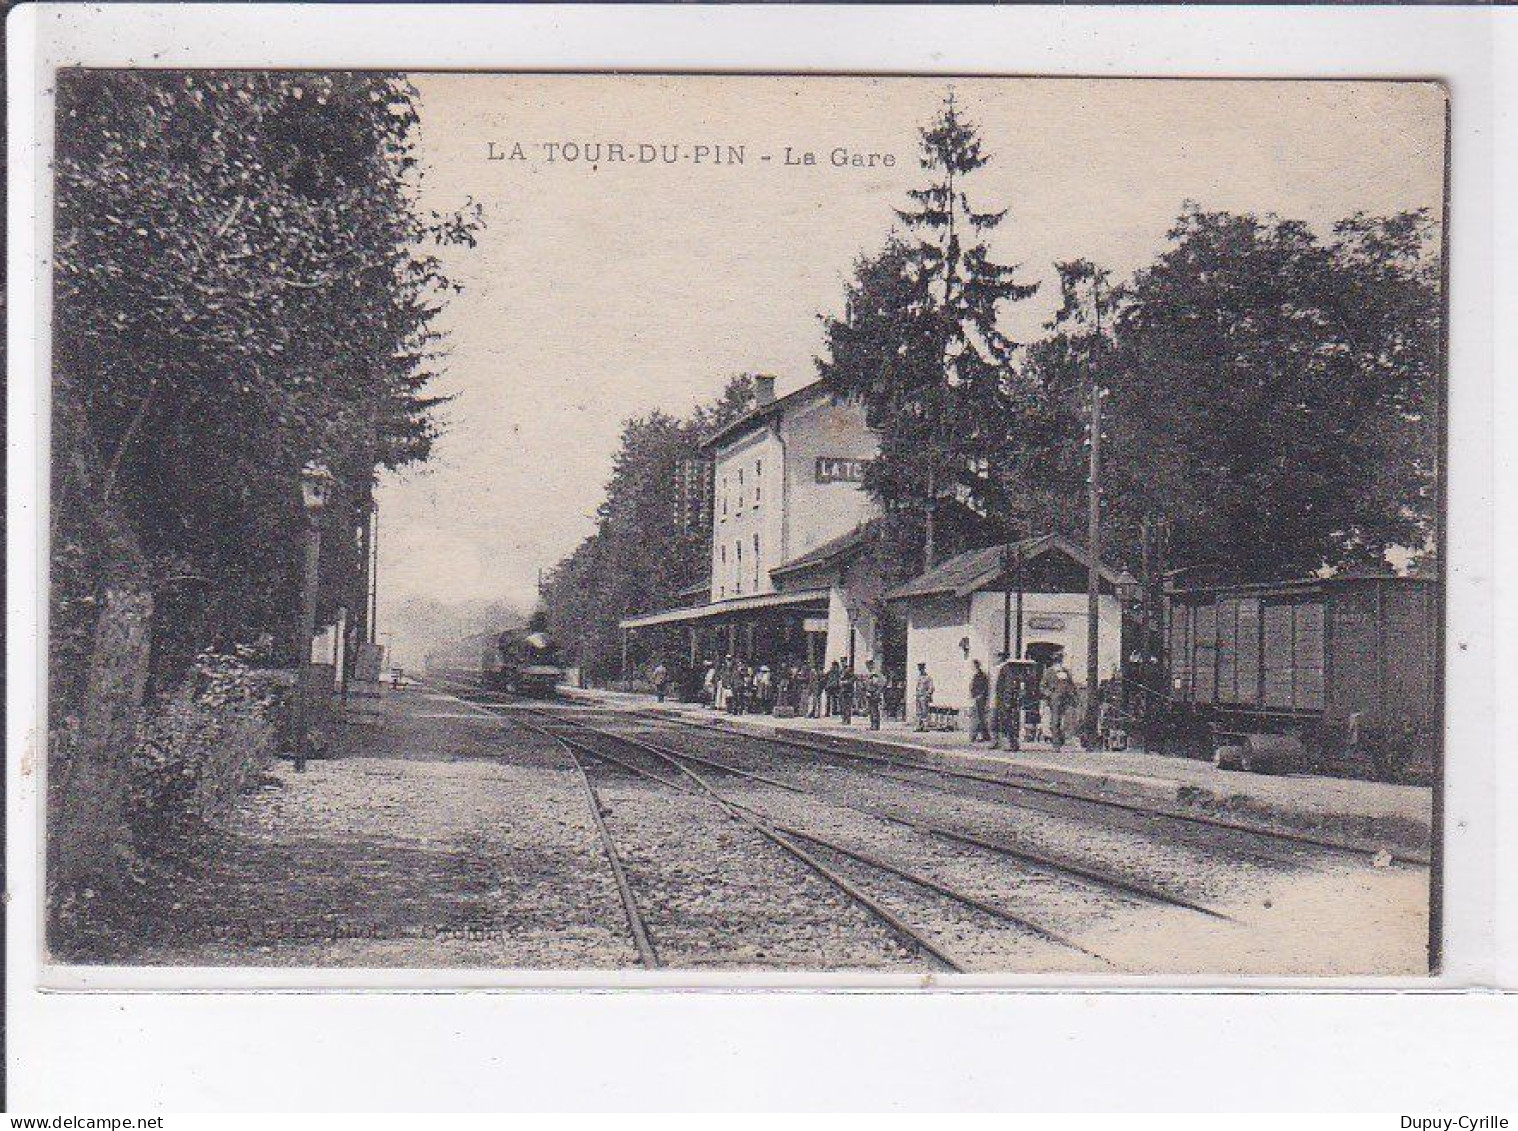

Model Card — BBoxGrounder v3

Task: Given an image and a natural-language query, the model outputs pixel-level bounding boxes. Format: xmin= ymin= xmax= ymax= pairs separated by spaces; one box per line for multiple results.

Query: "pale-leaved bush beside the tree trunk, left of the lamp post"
xmin=131 ymin=653 xmax=294 ymax=844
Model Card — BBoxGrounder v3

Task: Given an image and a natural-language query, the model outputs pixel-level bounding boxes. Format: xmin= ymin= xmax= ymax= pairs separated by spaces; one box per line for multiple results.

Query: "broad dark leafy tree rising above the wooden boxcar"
xmin=1104 ymin=206 xmax=1441 ymax=578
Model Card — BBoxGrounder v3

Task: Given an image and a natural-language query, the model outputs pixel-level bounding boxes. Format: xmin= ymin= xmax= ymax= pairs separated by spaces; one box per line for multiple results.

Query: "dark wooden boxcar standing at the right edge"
xmin=1166 ymin=575 xmax=1442 ymax=777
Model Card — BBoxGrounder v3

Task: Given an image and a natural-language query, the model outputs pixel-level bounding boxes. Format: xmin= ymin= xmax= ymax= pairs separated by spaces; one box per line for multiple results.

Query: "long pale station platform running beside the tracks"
xmin=560 ymin=688 xmax=1433 ymax=856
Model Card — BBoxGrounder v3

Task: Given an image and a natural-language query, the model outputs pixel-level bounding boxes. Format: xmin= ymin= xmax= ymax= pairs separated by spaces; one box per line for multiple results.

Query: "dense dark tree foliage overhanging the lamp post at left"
xmin=53 ymin=71 xmax=481 ymax=704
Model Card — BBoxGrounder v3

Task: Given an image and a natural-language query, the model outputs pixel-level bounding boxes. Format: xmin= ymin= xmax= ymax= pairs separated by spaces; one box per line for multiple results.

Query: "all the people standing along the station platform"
xmin=651 ymin=653 xmax=1081 ymax=750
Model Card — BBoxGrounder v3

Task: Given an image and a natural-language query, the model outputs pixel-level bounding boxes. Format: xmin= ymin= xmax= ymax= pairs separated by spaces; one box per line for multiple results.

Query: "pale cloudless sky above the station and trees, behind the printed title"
xmin=380 ymin=74 xmax=1444 ymax=649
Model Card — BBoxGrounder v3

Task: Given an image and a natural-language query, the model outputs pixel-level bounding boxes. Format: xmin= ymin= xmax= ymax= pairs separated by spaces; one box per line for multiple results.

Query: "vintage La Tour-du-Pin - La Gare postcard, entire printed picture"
xmin=44 ymin=68 xmax=1448 ymax=985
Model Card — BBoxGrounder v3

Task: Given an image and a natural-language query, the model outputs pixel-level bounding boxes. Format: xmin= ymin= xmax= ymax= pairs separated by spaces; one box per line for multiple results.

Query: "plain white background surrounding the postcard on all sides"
xmin=8 ymin=5 xmax=1518 ymax=1126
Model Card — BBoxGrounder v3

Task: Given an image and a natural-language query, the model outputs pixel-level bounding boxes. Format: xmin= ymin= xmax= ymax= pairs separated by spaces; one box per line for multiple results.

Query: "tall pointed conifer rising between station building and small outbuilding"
xmin=818 ymin=94 xmax=1037 ymax=566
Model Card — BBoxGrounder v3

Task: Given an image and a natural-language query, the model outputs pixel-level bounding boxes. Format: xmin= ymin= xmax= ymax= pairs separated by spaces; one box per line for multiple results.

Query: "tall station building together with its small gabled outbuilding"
xmin=621 ymin=378 xmax=1134 ymax=707
